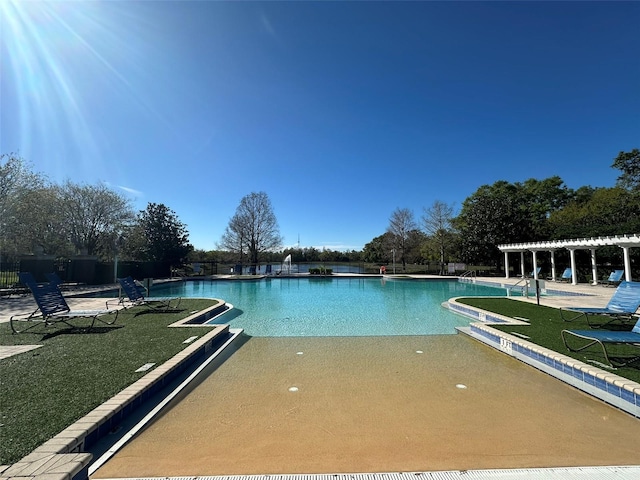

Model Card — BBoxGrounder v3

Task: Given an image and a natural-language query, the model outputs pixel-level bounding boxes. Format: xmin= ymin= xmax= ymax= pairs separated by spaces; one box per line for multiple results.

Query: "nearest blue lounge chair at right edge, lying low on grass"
xmin=561 ymin=320 xmax=640 ymax=367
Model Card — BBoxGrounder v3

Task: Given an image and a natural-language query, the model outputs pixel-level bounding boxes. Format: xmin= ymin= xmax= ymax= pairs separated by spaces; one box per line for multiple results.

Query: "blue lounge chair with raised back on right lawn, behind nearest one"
xmin=560 ymin=281 xmax=640 ymax=328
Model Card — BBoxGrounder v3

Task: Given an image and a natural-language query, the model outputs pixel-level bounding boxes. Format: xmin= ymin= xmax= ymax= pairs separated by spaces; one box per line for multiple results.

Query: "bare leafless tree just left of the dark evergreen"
xmin=58 ymin=181 xmax=133 ymax=257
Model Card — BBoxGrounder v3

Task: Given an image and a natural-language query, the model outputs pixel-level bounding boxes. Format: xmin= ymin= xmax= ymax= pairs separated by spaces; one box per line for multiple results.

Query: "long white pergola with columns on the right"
xmin=498 ymin=233 xmax=640 ymax=285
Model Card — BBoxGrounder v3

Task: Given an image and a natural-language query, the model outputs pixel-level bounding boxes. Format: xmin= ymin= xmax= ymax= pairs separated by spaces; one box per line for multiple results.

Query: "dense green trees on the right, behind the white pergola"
xmin=363 ymin=149 xmax=640 ymax=268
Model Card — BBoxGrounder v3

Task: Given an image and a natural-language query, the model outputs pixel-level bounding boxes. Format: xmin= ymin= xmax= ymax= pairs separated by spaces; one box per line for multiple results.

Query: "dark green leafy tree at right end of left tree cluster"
xmin=125 ymin=203 xmax=193 ymax=265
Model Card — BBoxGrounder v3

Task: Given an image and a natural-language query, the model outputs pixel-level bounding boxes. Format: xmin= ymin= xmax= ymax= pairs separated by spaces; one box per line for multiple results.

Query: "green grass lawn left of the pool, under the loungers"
xmin=0 ymin=299 xmax=220 ymax=465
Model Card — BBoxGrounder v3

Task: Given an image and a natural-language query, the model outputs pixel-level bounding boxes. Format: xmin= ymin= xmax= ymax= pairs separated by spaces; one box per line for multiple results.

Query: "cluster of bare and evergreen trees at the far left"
xmin=0 ymin=154 xmax=193 ymax=264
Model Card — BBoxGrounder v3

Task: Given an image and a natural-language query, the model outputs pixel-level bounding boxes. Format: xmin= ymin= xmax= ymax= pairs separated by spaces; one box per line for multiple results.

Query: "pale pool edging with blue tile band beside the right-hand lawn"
xmin=446 ymin=297 xmax=640 ymax=418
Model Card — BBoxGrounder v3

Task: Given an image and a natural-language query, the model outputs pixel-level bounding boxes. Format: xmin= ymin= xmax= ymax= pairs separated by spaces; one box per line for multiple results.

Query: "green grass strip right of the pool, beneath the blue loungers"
xmin=458 ymin=297 xmax=640 ymax=383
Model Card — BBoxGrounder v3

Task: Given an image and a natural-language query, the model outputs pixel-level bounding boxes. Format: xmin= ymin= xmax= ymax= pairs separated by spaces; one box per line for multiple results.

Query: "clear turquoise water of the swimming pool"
xmin=152 ymin=278 xmax=506 ymax=337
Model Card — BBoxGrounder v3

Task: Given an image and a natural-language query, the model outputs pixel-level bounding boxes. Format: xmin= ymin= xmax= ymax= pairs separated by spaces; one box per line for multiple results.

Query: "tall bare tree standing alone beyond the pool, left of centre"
xmin=220 ymin=192 xmax=282 ymax=265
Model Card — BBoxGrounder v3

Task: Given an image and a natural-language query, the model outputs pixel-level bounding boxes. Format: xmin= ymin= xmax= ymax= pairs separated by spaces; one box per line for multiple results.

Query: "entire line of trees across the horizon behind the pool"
xmin=0 ymin=149 xmax=640 ymax=273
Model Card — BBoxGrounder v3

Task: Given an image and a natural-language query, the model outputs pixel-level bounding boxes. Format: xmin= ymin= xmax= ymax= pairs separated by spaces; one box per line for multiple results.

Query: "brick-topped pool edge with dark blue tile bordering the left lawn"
xmin=0 ymin=302 xmax=242 ymax=480
